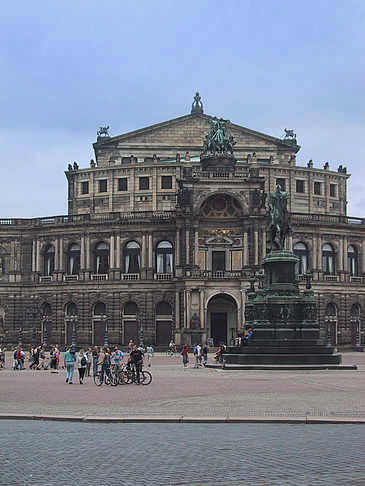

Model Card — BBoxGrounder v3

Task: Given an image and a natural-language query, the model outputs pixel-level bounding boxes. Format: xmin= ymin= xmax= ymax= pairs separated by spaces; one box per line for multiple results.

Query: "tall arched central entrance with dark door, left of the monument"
xmin=207 ymin=294 xmax=238 ymax=346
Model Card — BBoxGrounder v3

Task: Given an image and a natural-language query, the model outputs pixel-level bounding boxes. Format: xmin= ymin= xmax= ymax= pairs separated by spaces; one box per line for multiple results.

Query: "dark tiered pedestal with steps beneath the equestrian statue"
xmin=208 ymin=250 xmax=356 ymax=369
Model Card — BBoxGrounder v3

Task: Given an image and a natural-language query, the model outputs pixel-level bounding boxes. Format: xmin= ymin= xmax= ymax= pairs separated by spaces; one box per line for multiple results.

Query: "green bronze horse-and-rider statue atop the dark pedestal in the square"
xmin=268 ymin=184 xmax=291 ymax=251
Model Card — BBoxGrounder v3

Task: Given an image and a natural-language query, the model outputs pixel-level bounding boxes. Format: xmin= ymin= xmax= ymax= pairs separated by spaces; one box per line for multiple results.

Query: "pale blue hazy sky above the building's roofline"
xmin=0 ymin=0 xmax=365 ymax=218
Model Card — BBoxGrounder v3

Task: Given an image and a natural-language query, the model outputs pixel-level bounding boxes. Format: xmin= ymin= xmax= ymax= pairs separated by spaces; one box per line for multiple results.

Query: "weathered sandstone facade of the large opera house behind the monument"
xmin=0 ymin=106 xmax=365 ymax=346
